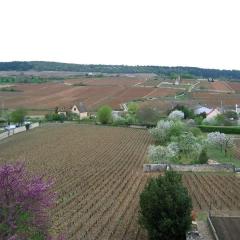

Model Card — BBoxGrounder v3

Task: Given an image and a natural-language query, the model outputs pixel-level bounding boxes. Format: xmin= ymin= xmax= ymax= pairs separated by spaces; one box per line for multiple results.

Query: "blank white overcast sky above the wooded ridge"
xmin=0 ymin=0 xmax=240 ymax=70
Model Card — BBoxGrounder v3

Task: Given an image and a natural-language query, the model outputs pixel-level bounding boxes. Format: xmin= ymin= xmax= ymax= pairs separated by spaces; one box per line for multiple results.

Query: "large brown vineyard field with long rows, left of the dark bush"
xmin=0 ymin=124 xmax=152 ymax=240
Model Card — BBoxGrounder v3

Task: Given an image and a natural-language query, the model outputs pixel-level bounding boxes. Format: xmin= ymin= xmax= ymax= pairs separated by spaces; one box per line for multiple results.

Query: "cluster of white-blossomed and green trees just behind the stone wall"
xmin=148 ymin=110 xmax=208 ymax=163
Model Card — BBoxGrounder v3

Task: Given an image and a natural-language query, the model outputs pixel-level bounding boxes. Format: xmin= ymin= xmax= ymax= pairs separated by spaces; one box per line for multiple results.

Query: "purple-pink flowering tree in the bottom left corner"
xmin=0 ymin=163 xmax=63 ymax=240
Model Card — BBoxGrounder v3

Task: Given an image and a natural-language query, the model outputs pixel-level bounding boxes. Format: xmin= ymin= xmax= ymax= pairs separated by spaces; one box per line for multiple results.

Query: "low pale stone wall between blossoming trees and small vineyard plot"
xmin=143 ymin=164 xmax=235 ymax=172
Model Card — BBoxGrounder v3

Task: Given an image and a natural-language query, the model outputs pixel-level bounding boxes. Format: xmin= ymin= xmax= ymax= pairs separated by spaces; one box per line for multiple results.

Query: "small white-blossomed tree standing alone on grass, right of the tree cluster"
xmin=207 ymin=132 xmax=234 ymax=156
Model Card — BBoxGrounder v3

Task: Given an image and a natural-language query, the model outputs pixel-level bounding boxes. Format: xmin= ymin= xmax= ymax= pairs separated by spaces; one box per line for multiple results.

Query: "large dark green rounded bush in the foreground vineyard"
xmin=139 ymin=171 xmax=192 ymax=240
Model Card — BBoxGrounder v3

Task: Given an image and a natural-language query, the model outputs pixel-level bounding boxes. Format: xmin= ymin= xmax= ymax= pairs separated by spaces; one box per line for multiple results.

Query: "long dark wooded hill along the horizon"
xmin=0 ymin=61 xmax=240 ymax=80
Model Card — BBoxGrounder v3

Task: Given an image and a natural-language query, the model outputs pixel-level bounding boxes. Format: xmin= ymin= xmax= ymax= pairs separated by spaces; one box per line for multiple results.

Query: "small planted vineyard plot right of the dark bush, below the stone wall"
xmin=183 ymin=173 xmax=240 ymax=211
